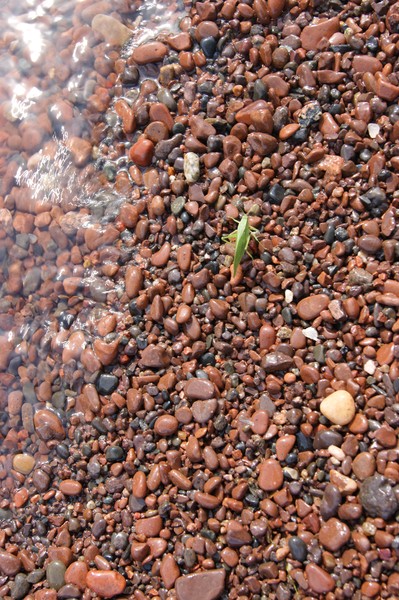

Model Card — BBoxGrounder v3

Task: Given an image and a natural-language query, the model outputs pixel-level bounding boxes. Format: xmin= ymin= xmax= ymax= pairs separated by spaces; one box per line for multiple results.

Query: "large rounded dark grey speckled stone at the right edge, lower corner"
xmin=359 ymin=473 xmax=399 ymax=520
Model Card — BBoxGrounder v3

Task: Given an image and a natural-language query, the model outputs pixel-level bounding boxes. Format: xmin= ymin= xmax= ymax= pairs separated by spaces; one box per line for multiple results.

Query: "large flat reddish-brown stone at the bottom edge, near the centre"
xmin=175 ymin=569 xmax=226 ymax=600
